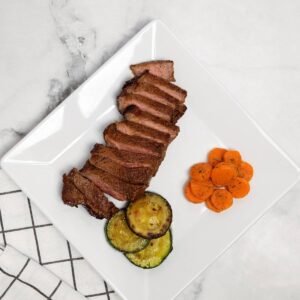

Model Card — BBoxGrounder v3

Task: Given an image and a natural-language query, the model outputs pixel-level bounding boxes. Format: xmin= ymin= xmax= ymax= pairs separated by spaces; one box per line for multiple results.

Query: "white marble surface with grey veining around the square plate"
xmin=0 ymin=0 xmax=300 ymax=300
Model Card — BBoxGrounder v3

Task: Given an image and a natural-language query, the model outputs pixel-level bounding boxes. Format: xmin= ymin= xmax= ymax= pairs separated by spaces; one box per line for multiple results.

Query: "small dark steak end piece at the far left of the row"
xmin=62 ymin=171 xmax=85 ymax=207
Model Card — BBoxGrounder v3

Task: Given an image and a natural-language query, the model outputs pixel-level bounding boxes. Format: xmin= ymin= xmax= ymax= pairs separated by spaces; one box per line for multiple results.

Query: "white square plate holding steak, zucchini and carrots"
xmin=1 ymin=21 xmax=298 ymax=300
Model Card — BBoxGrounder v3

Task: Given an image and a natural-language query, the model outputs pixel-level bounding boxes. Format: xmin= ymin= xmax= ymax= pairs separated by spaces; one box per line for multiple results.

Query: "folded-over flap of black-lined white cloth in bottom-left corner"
xmin=0 ymin=245 xmax=85 ymax=300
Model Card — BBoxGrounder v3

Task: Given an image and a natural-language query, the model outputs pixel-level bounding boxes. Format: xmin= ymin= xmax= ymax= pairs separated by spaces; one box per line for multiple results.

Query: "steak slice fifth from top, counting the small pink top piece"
xmin=124 ymin=107 xmax=179 ymax=140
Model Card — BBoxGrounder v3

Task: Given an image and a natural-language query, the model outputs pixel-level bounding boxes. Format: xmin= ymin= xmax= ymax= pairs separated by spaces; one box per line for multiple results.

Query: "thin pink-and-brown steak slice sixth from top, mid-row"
xmin=116 ymin=120 xmax=171 ymax=147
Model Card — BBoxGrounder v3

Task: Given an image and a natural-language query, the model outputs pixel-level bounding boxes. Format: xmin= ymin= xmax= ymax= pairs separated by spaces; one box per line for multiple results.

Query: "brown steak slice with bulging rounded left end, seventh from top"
xmin=103 ymin=123 xmax=165 ymax=158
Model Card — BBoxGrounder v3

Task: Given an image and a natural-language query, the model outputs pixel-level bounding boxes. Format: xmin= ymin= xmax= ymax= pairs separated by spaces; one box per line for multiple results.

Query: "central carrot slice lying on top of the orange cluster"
xmin=211 ymin=162 xmax=237 ymax=186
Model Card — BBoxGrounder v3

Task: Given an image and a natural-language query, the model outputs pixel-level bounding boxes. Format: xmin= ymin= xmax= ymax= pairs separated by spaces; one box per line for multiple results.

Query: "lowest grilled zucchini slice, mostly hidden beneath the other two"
xmin=125 ymin=230 xmax=173 ymax=269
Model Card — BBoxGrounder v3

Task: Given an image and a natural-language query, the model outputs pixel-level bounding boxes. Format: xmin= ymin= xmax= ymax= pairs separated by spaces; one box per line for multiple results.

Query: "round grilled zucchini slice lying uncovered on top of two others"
xmin=126 ymin=192 xmax=172 ymax=239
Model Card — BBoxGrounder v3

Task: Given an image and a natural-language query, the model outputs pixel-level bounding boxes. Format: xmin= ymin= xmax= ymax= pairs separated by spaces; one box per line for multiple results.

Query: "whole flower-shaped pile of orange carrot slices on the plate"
xmin=184 ymin=148 xmax=254 ymax=207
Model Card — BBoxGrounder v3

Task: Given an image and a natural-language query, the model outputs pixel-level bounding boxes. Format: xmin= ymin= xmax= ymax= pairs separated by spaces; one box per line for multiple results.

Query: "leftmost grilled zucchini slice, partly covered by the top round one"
xmin=105 ymin=210 xmax=149 ymax=253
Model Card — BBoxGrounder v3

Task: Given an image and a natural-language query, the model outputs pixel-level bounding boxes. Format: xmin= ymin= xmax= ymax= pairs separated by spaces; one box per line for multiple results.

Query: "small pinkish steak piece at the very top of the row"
xmin=130 ymin=60 xmax=175 ymax=81
